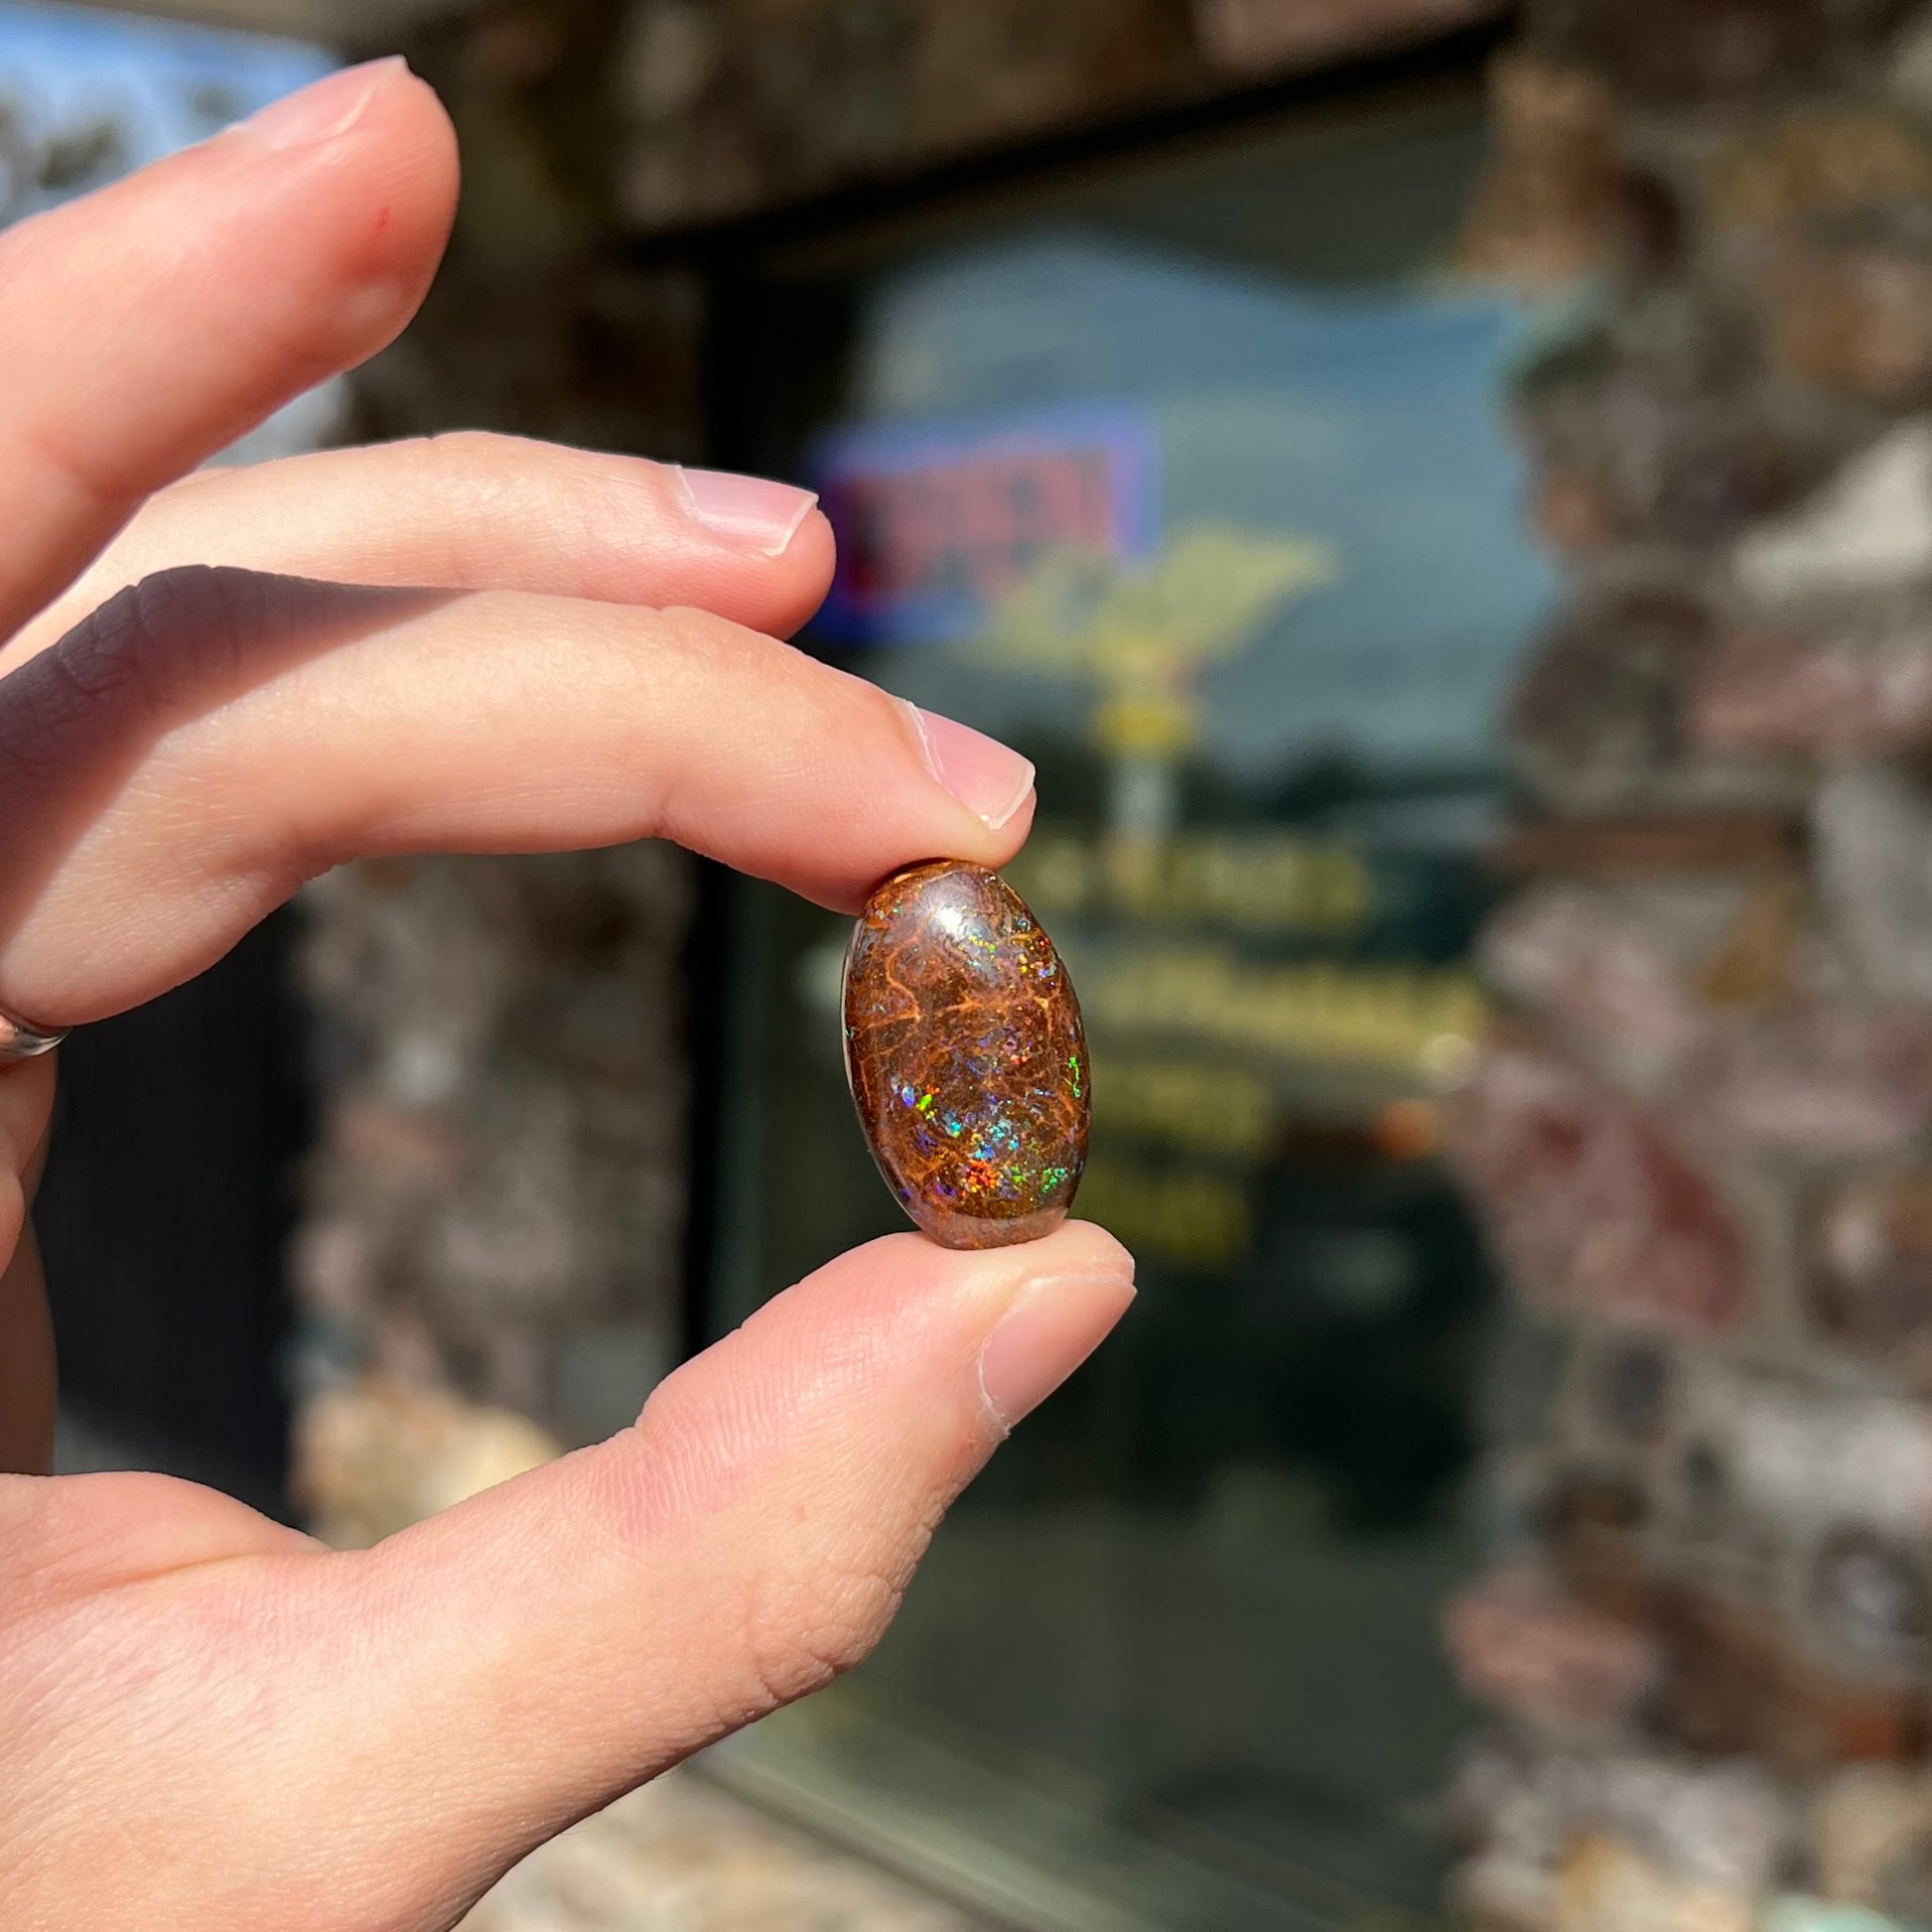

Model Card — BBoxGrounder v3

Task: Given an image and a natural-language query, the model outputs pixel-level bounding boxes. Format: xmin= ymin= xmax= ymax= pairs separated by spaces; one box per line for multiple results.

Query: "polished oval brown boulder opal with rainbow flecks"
xmin=844 ymin=860 xmax=1090 ymax=1248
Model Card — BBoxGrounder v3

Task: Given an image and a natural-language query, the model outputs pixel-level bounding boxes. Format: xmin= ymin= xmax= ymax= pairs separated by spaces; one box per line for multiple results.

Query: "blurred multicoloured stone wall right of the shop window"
xmin=1449 ymin=0 xmax=1932 ymax=1932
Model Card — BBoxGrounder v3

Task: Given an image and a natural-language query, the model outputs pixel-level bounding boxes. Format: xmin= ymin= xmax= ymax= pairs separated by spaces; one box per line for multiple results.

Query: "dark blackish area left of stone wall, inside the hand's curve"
xmin=35 ymin=912 xmax=307 ymax=1515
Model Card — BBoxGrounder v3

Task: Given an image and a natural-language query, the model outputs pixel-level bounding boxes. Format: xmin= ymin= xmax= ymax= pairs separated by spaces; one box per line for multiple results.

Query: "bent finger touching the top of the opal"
xmin=0 ymin=570 xmax=1034 ymax=1028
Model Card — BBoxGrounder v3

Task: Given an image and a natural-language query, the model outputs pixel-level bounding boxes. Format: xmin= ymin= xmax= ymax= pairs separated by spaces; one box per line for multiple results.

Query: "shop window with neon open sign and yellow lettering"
xmin=709 ymin=64 xmax=1552 ymax=1926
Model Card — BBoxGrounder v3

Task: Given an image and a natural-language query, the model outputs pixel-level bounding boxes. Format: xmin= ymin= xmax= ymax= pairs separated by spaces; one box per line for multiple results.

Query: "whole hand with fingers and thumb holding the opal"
xmin=0 ymin=66 xmax=1132 ymax=1932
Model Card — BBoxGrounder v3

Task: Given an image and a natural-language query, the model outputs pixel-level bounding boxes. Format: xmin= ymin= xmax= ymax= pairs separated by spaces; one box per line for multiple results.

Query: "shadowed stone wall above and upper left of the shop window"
xmin=344 ymin=0 xmax=1505 ymax=458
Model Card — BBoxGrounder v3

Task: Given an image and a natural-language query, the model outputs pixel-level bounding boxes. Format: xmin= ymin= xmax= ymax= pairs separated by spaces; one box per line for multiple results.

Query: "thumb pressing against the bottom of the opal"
xmin=317 ymin=1223 xmax=1134 ymax=1908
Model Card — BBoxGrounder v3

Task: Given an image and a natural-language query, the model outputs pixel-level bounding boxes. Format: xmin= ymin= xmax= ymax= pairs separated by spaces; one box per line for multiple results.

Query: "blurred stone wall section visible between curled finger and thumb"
xmin=294 ymin=844 xmax=690 ymax=1544
